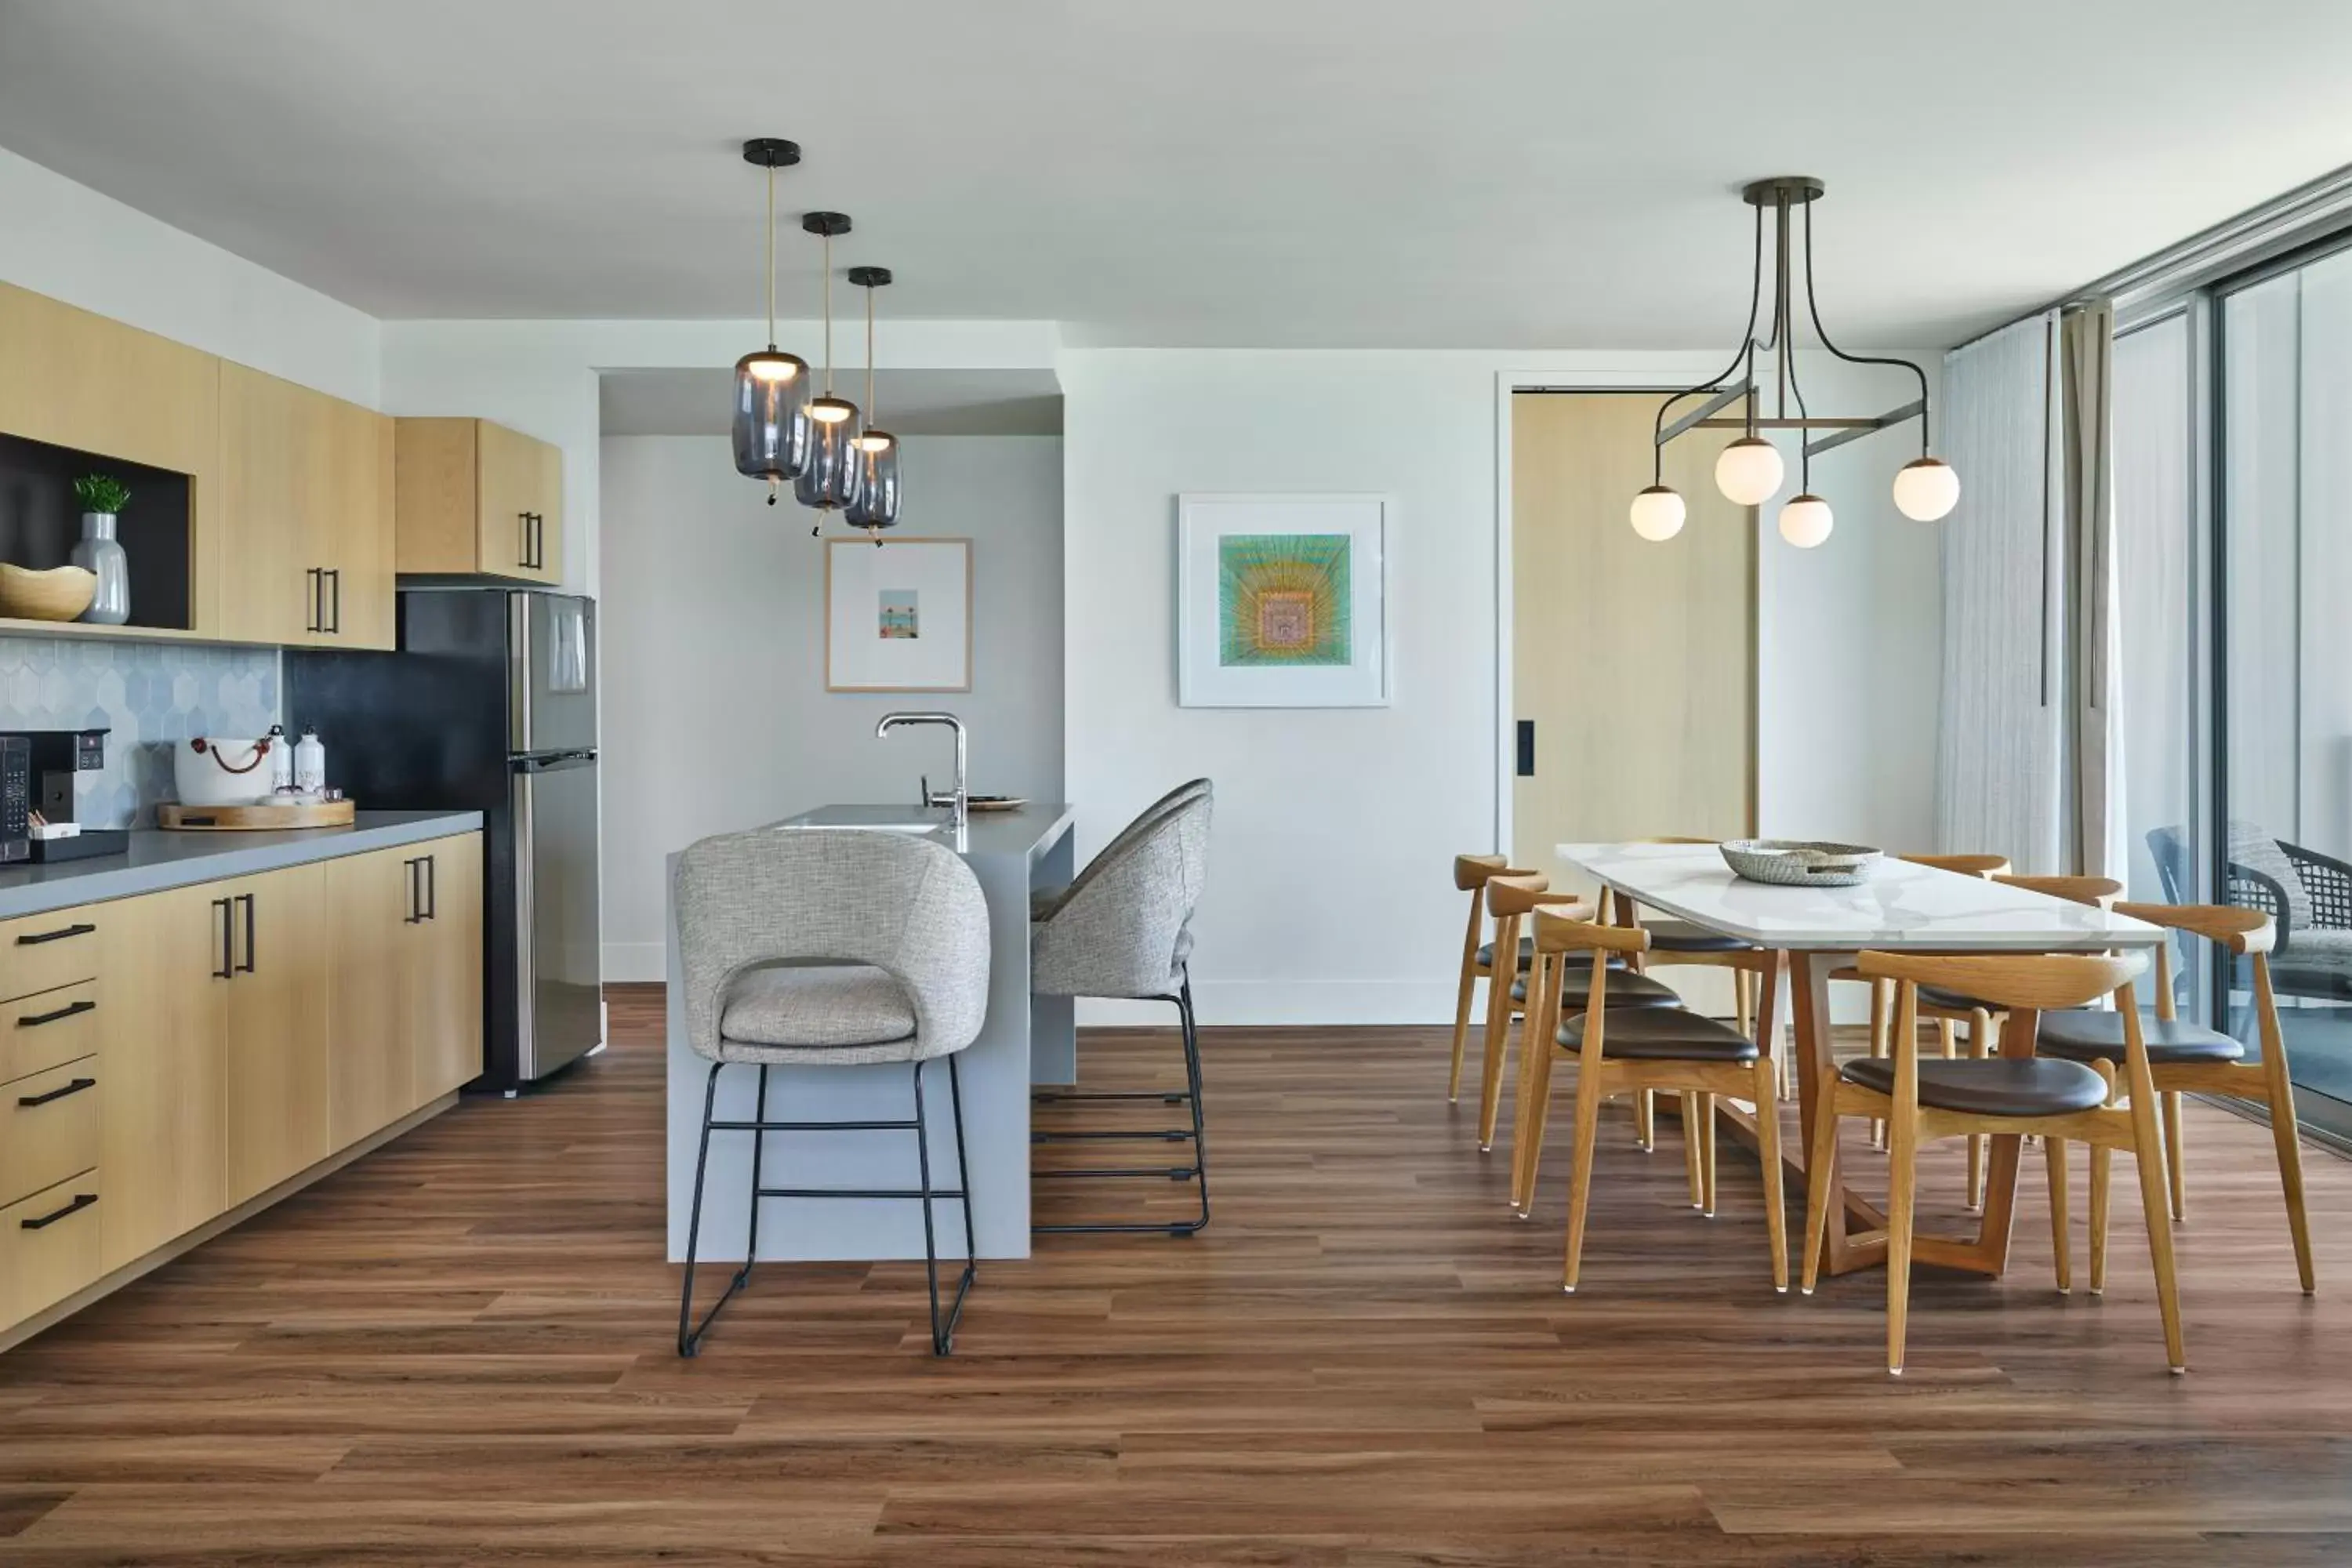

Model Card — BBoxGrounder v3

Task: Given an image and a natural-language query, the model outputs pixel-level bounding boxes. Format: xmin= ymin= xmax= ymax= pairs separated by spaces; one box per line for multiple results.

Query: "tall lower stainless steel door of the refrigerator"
xmin=513 ymin=757 xmax=604 ymax=1081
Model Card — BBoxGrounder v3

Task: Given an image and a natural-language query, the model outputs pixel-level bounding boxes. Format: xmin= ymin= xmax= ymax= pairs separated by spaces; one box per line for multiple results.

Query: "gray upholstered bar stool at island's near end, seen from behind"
xmin=677 ymin=827 xmax=988 ymax=1356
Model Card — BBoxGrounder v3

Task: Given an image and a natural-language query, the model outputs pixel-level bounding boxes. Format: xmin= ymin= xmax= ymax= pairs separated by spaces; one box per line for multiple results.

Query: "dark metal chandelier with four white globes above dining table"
xmin=1630 ymin=174 xmax=1959 ymax=550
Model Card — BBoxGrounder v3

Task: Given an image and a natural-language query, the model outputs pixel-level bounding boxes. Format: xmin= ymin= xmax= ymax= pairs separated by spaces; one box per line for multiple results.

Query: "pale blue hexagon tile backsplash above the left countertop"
xmin=0 ymin=637 xmax=278 ymax=827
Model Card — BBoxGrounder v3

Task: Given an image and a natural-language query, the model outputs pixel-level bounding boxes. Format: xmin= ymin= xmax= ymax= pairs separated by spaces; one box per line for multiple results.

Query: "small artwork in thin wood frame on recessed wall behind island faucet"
xmin=826 ymin=539 xmax=971 ymax=691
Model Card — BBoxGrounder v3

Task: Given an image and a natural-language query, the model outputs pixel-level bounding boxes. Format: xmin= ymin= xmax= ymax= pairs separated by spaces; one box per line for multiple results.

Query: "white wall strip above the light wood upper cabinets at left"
xmin=0 ymin=151 xmax=381 ymax=409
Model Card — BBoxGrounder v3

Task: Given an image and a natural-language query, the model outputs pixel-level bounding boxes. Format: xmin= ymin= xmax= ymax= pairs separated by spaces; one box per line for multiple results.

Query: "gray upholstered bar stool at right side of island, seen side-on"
xmin=1030 ymin=779 xmax=1214 ymax=1236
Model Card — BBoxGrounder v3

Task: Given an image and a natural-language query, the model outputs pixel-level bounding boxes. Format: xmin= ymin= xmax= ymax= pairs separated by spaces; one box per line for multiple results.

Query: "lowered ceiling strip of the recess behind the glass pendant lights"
xmin=597 ymin=369 xmax=1061 ymax=435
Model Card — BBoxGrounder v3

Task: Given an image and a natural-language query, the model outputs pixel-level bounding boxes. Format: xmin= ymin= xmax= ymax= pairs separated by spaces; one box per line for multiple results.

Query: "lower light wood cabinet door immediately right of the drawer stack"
xmin=85 ymin=884 xmax=235 ymax=1269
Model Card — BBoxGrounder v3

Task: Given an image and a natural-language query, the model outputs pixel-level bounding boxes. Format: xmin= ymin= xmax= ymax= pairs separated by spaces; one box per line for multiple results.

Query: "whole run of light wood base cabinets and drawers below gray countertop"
xmin=0 ymin=832 xmax=482 ymax=1347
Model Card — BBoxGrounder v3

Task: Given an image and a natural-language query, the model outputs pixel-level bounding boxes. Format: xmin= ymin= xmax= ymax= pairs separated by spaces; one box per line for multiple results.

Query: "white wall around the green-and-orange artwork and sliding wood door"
xmin=1061 ymin=350 xmax=1940 ymax=1022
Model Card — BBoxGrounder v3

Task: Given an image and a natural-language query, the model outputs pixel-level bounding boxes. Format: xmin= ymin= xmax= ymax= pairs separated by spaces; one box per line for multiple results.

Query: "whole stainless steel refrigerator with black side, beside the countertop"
xmin=285 ymin=588 xmax=604 ymax=1093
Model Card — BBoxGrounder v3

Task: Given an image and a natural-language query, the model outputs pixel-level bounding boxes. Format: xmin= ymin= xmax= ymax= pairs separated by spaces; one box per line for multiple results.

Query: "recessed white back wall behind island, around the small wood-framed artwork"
xmin=600 ymin=423 xmax=1063 ymax=980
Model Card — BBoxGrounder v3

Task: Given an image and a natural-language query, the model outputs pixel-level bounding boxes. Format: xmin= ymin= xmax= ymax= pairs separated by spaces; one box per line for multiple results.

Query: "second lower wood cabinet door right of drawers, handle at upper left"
xmin=214 ymin=865 xmax=329 ymax=1203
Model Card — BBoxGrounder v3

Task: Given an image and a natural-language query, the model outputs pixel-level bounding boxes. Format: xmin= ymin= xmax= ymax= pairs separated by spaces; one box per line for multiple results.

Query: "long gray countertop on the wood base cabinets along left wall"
xmin=0 ymin=811 xmax=482 ymax=919
